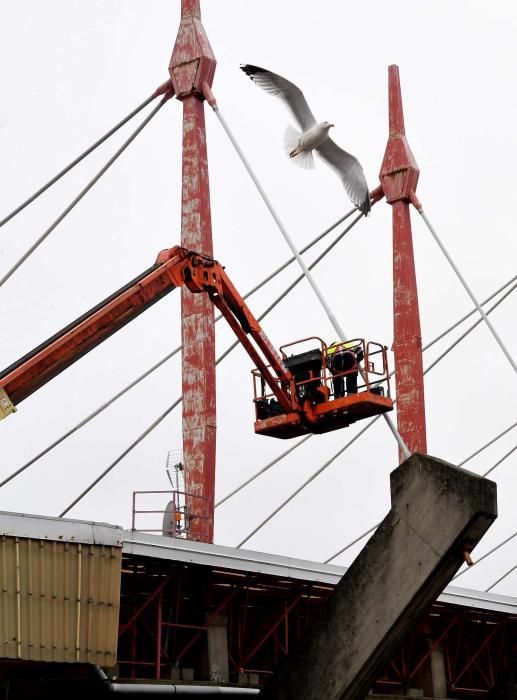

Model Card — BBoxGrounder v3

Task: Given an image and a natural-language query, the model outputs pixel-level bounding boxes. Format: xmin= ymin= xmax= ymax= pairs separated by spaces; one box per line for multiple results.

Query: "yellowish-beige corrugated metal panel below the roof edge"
xmin=0 ymin=535 xmax=122 ymax=667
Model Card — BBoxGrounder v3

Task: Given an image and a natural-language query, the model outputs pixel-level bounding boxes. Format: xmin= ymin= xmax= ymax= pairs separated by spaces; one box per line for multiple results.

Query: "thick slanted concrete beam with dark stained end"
xmin=260 ymin=454 xmax=497 ymax=700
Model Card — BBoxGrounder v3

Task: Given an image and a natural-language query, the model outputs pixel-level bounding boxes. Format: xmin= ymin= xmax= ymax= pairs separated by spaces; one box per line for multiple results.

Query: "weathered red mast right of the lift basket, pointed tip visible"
xmin=379 ymin=66 xmax=427 ymax=461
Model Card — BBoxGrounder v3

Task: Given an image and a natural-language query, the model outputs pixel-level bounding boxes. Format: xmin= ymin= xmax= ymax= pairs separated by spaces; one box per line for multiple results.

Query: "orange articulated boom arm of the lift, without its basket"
xmin=0 ymin=246 xmax=298 ymax=418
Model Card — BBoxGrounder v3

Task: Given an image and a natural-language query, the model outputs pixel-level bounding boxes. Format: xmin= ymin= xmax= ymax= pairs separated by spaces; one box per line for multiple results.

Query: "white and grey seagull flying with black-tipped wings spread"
xmin=241 ymin=64 xmax=371 ymax=216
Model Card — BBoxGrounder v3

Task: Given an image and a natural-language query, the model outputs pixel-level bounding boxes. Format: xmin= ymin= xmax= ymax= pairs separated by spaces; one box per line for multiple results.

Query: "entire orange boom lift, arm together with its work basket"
xmin=0 ymin=246 xmax=393 ymax=438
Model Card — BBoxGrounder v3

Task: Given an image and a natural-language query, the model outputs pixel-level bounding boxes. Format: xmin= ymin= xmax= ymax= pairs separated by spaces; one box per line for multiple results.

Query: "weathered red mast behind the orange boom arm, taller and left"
xmin=169 ymin=0 xmax=216 ymax=542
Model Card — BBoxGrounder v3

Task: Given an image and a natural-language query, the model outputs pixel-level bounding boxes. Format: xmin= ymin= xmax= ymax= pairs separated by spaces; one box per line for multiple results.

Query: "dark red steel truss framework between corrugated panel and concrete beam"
xmin=118 ymin=556 xmax=326 ymax=680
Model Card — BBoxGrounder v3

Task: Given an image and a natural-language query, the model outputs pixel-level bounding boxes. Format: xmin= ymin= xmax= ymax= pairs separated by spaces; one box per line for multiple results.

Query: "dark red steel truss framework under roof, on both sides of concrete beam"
xmin=118 ymin=555 xmax=517 ymax=698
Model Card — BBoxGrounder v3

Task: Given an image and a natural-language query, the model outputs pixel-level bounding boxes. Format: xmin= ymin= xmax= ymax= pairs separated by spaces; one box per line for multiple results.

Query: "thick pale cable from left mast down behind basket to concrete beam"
xmin=211 ymin=101 xmax=409 ymax=457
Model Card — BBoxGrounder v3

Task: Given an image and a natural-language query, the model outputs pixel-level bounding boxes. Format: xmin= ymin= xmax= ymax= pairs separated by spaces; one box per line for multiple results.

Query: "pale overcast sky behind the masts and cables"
xmin=0 ymin=0 xmax=517 ymax=594
